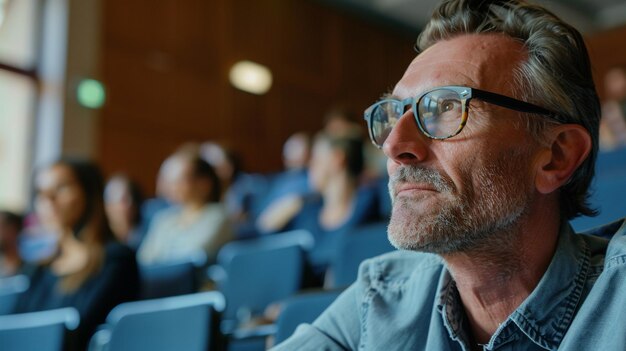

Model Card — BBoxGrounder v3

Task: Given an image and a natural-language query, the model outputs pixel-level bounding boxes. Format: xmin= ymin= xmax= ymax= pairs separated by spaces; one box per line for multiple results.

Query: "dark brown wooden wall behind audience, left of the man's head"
xmin=99 ymin=0 xmax=415 ymax=193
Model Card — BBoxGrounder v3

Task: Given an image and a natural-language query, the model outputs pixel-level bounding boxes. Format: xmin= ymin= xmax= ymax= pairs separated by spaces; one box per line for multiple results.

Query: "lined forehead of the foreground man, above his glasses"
xmin=394 ymin=34 xmax=526 ymax=97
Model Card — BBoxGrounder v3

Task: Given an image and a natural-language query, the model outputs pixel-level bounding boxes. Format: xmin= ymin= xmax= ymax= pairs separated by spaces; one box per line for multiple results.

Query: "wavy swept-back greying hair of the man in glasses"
xmin=416 ymin=0 xmax=600 ymax=219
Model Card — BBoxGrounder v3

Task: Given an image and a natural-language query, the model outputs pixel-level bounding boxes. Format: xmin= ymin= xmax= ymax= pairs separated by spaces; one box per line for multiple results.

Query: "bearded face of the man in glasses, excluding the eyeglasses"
xmin=383 ymin=34 xmax=533 ymax=254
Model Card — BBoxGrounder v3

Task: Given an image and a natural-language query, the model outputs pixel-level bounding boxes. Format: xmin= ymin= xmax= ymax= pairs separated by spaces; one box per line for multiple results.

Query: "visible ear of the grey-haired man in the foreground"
xmin=535 ymin=124 xmax=592 ymax=194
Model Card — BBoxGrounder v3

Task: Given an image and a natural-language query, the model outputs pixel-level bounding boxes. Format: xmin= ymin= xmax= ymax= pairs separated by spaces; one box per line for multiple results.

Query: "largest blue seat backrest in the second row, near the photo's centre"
xmin=217 ymin=230 xmax=313 ymax=320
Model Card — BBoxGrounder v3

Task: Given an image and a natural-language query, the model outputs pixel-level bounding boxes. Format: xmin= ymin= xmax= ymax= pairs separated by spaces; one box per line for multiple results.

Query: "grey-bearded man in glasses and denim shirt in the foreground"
xmin=276 ymin=0 xmax=626 ymax=351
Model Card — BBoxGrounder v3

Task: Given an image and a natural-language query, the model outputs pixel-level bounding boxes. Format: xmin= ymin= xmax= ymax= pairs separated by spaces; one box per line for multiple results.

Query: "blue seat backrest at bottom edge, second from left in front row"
xmin=107 ymin=291 xmax=225 ymax=351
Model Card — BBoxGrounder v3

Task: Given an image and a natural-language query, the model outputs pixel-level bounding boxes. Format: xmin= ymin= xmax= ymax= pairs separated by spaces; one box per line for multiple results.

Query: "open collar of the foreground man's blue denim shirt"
xmin=437 ymin=222 xmax=590 ymax=349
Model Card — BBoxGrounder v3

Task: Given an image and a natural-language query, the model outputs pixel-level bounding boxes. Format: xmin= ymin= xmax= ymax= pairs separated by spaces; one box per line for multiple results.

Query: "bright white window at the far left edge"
xmin=0 ymin=0 xmax=40 ymax=211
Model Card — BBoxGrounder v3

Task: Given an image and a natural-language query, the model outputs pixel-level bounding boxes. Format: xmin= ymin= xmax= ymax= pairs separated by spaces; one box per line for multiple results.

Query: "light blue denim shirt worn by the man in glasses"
xmin=273 ymin=220 xmax=626 ymax=351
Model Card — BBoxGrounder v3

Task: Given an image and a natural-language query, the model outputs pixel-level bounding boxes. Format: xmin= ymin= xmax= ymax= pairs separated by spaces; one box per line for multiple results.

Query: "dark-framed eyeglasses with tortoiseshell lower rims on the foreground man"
xmin=364 ymin=86 xmax=556 ymax=148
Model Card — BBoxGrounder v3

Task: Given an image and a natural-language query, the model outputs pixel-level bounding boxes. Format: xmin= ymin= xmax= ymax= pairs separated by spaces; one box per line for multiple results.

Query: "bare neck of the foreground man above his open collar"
xmin=444 ymin=209 xmax=559 ymax=343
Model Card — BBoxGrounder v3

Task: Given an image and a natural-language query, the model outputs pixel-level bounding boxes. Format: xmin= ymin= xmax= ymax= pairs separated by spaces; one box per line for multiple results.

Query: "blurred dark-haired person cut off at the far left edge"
xmin=0 ymin=211 xmax=22 ymax=278
